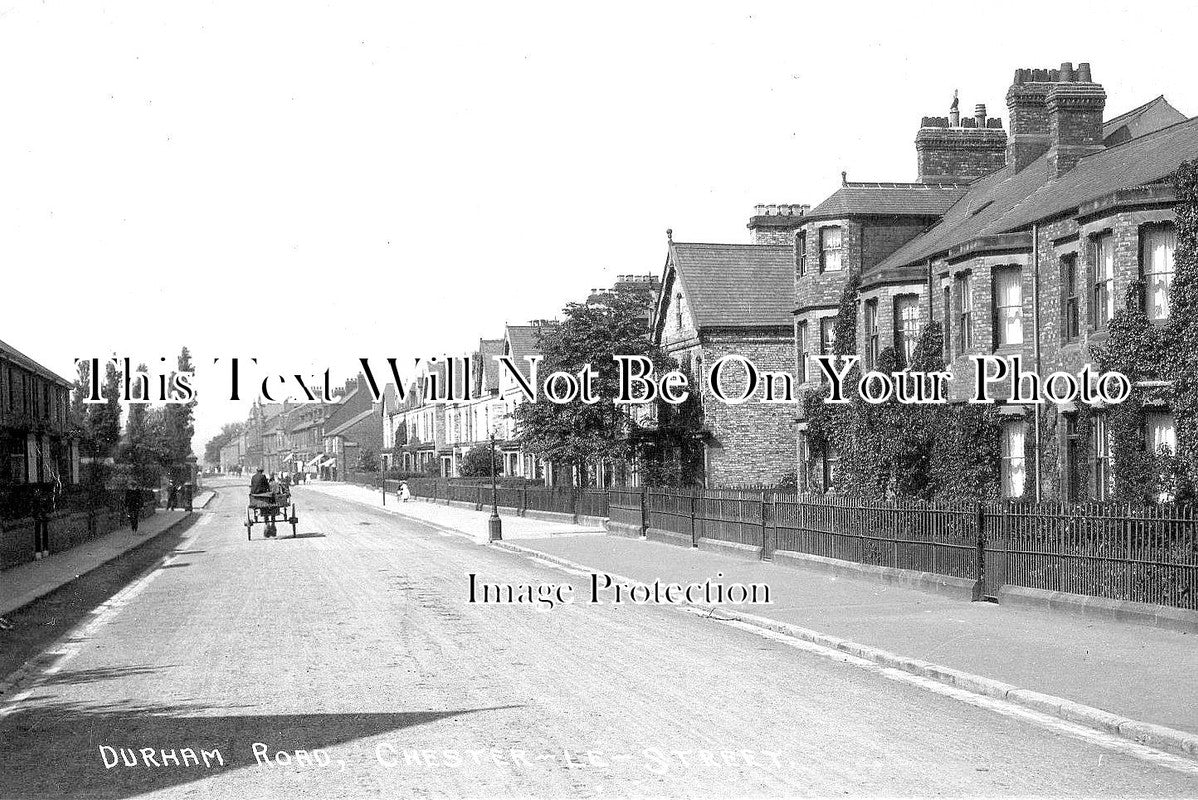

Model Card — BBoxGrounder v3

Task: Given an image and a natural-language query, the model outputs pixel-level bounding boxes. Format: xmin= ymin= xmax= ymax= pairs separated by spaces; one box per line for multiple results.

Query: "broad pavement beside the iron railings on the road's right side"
xmin=318 ymin=486 xmax=1198 ymax=742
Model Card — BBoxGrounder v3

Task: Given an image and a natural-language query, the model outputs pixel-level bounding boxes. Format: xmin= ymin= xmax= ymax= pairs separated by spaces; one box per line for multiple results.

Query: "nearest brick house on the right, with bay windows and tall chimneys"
xmin=795 ymin=63 xmax=1198 ymax=499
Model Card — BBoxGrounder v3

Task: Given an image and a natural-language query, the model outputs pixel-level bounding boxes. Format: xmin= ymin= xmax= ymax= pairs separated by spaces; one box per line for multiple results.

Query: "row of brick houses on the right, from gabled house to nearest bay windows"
xmin=653 ymin=63 xmax=1198 ymax=499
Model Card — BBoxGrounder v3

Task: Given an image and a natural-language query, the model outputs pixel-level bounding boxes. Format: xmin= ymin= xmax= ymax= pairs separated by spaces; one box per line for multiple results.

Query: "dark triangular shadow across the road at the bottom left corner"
xmin=0 ymin=698 xmax=519 ymax=798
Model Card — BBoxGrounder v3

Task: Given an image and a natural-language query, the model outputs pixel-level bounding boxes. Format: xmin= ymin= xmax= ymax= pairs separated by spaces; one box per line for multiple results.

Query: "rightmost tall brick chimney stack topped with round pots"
xmin=1046 ymin=62 xmax=1107 ymax=180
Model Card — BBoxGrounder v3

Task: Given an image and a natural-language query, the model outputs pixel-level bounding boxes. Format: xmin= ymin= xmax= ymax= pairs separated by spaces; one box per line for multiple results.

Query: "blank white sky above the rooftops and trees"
xmin=0 ymin=0 xmax=1198 ymax=453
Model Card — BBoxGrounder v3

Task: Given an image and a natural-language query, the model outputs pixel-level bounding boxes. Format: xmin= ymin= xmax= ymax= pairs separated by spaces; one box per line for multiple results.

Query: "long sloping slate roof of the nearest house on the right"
xmin=871 ymin=117 xmax=1198 ymax=272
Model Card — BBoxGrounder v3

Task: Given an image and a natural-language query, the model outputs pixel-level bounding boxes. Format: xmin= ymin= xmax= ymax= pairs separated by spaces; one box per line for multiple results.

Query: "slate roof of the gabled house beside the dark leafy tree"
xmin=670 ymin=242 xmax=794 ymax=328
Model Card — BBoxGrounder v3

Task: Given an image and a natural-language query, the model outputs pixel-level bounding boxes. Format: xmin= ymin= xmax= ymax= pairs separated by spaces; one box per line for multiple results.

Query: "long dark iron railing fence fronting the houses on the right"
xmin=390 ymin=479 xmax=1198 ymax=610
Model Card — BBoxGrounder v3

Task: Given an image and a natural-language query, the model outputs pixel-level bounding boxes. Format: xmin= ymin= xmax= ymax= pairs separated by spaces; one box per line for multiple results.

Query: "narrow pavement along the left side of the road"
xmin=0 ymin=491 xmax=214 ymax=617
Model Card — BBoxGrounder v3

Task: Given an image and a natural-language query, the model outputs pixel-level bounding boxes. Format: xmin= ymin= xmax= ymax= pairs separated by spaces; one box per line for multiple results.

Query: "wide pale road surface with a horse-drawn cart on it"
xmin=0 ymin=485 xmax=1198 ymax=798
